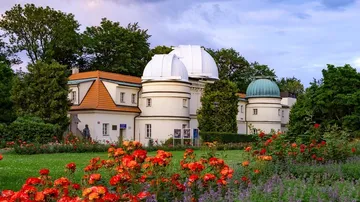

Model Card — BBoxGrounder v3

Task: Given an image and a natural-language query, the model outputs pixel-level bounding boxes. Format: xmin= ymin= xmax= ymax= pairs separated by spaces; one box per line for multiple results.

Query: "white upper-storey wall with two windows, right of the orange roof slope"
xmin=102 ymin=81 xmax=139 ymax=106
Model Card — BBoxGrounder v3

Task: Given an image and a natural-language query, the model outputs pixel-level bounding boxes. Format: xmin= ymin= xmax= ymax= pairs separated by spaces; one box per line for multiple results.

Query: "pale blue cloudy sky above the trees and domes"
xmin=0 ymin=0 xmax=360 ymax=86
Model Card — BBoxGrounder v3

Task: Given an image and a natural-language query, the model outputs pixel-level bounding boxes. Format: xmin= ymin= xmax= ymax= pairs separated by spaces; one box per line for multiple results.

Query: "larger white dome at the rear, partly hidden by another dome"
xmin=170 ymin=45 xmax=219 ymax=79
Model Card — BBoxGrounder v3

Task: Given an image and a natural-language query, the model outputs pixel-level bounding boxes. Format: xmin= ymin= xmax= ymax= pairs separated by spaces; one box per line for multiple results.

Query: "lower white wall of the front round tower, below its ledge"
xmin=136 ymin=117 xmax=192 ymax=145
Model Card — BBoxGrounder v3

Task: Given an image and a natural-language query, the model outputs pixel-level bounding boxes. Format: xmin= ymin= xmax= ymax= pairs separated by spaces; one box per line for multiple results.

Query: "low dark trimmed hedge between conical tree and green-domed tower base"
xmin=200 ymin=132 xmax=256 ymax=144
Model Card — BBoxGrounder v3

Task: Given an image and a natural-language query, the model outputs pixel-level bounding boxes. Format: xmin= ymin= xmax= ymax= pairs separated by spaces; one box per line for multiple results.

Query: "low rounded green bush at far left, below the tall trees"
xmin=0 ymin=117 xmax=62 ymax=144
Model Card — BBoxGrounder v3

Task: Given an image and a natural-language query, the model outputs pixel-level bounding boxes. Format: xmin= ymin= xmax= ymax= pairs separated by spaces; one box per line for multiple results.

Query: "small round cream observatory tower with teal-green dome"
xmin=246 ymin=78 xmax=281 ymax=134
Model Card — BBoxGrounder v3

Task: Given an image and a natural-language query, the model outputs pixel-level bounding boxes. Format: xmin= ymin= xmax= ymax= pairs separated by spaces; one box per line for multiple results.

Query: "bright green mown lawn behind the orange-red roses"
xmin=0 ymin=150 xmax=243 ymax=190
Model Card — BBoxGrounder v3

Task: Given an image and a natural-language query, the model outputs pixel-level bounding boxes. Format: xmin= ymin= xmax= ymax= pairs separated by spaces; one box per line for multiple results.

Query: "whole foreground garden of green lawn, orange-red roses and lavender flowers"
xmin=0 ymin=124 xmax=360 ymax=201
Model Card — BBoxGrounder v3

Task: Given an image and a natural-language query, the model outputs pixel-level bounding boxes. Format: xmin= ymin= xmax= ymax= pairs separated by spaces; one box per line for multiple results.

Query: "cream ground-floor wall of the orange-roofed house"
xmin=72 ymin=111 xmax=136 ymax=142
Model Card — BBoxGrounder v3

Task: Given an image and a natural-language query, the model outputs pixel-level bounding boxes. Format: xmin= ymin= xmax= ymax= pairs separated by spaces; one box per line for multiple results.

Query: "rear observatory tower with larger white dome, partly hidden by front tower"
xmin=170 ymin=45 xmax=219 ymax=129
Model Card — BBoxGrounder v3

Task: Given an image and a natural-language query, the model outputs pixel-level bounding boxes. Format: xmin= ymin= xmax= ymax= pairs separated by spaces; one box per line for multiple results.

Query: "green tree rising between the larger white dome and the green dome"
xmin=206 ymin=48 xmax=276 ymax=92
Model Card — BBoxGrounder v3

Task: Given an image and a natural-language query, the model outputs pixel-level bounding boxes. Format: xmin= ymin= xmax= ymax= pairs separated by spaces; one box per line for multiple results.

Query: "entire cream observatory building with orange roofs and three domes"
xmin=69 ymin=45 xmax=295 ymax=145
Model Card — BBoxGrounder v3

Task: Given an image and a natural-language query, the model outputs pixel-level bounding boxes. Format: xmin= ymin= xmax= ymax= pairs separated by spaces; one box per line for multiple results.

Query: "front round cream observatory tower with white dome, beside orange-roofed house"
xmin=136 ymin=54 xmax=190 ymax=145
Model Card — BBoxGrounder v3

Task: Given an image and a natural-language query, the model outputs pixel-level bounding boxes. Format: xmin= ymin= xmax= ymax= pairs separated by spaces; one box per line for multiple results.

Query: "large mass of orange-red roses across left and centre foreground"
xmin=0 ymin=141 xmax=234 ymax=201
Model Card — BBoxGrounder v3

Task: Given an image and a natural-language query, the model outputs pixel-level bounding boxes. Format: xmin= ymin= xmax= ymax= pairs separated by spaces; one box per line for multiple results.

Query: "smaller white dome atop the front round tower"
xmin=141 ymin=54 xmax=189 ymax=82
